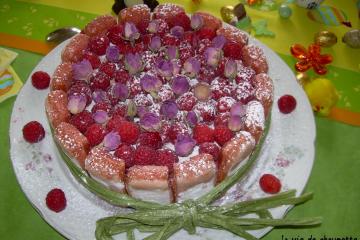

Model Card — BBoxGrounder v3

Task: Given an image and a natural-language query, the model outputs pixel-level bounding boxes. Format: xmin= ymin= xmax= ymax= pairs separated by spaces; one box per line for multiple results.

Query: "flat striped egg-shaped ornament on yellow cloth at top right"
xmin=307 ymin=5 xmax=351 ymax=27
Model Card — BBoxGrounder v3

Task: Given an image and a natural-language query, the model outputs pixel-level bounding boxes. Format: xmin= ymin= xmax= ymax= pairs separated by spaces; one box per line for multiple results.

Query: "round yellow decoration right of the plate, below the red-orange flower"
xmin=304 ymin=78 xmax=339 ymax=116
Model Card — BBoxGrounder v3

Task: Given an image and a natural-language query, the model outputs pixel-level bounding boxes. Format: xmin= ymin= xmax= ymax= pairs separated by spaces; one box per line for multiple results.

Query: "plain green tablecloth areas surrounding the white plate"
xmin=0 ymin=1 xmax=360 ymax=240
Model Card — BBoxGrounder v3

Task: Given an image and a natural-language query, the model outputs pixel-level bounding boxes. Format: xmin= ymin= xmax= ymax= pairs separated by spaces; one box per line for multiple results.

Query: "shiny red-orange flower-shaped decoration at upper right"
xmin=290 ymin=44 xmax=332 ymax=75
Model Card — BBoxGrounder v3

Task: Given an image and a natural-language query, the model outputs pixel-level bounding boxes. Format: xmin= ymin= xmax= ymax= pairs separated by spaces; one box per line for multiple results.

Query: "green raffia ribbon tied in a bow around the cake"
xmin=58 ymin=117 xmax=322 ymax=240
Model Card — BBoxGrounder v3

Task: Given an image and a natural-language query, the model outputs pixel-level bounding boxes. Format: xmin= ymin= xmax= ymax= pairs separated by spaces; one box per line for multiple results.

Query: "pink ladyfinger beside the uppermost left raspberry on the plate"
xmin=50 ymin=62 xmax=72 ymax=92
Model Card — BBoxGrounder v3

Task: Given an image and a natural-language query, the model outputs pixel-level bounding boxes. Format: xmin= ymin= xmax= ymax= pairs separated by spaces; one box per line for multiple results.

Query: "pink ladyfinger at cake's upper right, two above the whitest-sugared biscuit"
xmin=241 ymin=45 xmax=269 ymax=74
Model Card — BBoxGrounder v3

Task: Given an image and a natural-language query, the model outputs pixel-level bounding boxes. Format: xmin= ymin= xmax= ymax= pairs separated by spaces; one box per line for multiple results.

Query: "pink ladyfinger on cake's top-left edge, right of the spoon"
xmin=84 ymin=15 xmax=117 ymax=37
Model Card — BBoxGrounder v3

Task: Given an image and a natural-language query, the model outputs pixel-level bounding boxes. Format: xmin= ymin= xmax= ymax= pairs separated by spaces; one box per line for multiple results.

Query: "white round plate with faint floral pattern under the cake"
xmin=10 ymin=34 xmax=315 ymax=240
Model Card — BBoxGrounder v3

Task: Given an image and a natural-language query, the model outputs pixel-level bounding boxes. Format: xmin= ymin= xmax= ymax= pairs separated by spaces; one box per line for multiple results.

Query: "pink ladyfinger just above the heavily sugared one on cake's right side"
xmin=252 ymin=73 xmax=274 ymax=117
